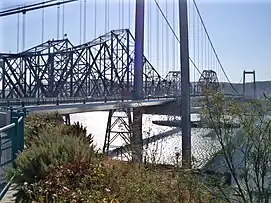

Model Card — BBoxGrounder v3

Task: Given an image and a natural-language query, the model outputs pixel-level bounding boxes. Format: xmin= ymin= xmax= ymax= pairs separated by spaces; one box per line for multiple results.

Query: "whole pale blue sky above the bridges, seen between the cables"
xmin=0 ymin=0 xmax=271 ymax=82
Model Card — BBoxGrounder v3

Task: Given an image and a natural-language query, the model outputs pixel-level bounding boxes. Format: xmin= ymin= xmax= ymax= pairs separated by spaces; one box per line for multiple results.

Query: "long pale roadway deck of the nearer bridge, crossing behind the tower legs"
xmin=0 ymin=96 xmax=246 ymax=116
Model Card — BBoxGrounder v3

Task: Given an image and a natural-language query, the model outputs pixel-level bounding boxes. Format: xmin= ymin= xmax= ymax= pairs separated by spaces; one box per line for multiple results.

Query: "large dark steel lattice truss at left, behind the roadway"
xmin=0 ymin=30 xmax=180 ymax=98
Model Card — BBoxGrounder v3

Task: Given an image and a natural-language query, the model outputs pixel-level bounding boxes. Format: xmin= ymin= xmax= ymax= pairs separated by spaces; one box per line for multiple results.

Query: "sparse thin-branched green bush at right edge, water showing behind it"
xmin=202 ymin=91 xmax=271 ymax=203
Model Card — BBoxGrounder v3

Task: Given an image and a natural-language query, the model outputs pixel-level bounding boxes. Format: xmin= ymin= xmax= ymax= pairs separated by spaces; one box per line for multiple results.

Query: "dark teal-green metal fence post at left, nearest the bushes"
xmin=10 ymin=109 xmax=18 ymax=165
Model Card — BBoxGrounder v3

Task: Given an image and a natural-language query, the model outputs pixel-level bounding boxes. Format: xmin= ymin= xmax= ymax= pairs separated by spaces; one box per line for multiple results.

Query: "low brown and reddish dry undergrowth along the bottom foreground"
xmin=19 ymin=159 xmax=223 ymax=203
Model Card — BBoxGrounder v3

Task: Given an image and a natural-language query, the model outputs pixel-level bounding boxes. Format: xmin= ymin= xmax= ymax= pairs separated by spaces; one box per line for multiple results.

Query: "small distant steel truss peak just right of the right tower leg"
xmin=196 ymin=70 xmax=219 ymax=94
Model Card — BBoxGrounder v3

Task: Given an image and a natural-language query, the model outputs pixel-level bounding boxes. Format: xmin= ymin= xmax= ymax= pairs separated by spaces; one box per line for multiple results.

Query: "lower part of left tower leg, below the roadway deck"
xmin=131 ymin=108 xmax=143 ymax=163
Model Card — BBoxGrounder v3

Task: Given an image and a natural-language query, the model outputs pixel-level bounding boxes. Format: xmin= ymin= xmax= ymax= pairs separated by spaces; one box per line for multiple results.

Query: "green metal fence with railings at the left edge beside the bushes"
xmin=0 ymin=108 xmax=26 ymax=200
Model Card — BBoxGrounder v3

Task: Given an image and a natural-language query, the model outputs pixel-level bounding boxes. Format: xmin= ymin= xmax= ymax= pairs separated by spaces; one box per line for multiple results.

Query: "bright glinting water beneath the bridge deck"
xmin=71 ymin=112 xmax=221 ymax=166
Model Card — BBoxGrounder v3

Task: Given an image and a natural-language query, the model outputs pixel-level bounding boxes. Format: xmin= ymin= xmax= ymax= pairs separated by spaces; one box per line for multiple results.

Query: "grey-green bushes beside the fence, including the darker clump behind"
xmin=6 ymin=113 xmax=97 ymax=201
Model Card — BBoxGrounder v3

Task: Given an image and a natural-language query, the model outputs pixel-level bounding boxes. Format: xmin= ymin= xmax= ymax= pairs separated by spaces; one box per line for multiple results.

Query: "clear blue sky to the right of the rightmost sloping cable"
xmin=200 ymin=0 xmax=271 ymax=80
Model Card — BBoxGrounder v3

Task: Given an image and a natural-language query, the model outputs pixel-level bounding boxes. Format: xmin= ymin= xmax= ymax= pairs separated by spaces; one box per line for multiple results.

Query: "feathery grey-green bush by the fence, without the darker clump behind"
xmin=7 ymin=127 xmax=96 ymax=201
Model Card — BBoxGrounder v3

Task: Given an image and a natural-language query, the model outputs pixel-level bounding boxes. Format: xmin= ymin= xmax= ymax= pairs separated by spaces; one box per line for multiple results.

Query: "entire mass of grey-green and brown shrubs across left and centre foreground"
xmin=7 ymin=111 xmax=230 ymax=203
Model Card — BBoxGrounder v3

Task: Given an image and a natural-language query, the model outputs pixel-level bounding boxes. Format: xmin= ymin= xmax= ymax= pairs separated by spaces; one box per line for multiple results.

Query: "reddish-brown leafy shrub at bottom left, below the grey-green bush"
xmin=21 ymin=161 xmax=107 ymax=202
